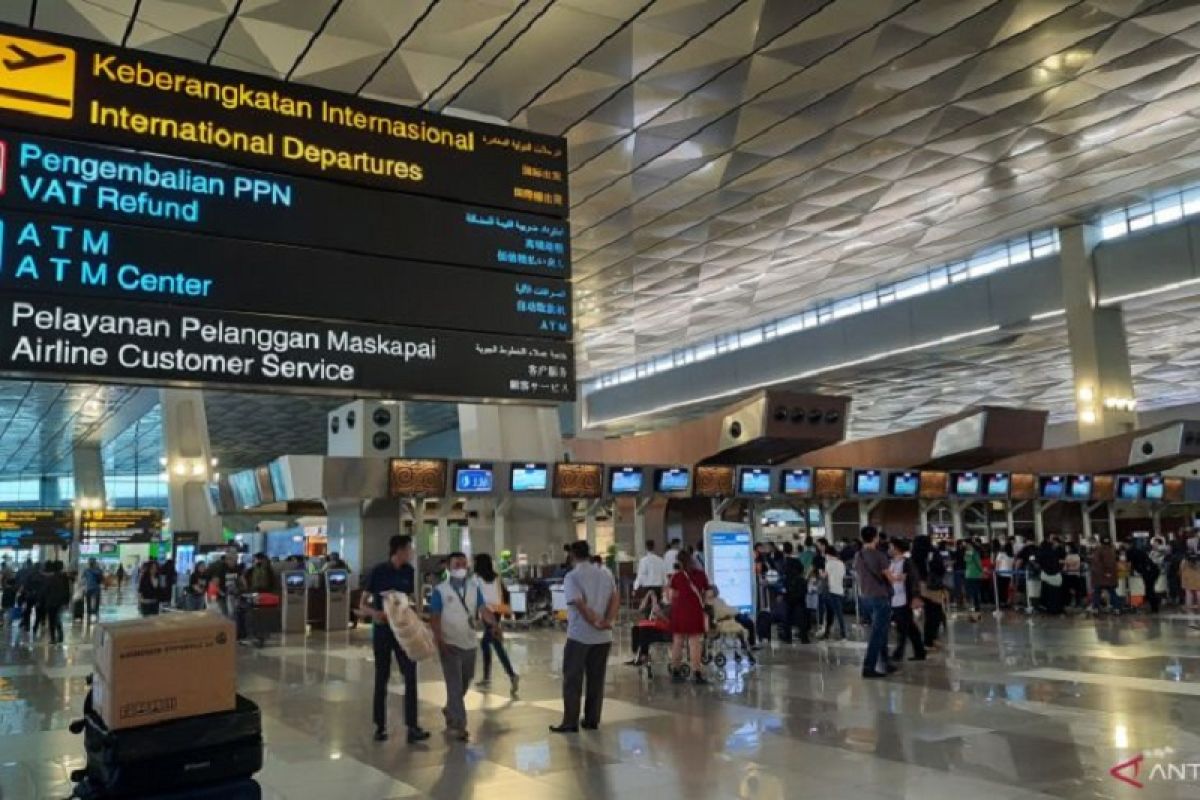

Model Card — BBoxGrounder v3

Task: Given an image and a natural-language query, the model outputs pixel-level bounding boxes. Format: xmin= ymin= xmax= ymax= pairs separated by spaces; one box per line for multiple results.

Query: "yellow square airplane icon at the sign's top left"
xmin=0 ymin=35 xmax=76 ymax=120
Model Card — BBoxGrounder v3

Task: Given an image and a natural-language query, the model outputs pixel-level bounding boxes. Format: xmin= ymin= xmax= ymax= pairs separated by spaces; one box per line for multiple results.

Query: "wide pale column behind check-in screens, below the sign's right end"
xmin=458 ymin=403 xmax=575 ymax=563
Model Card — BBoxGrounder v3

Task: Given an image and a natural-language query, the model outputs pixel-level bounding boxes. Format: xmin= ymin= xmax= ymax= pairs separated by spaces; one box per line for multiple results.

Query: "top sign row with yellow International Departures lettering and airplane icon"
xmin=0 ymin=25 xmax=569 ymax=218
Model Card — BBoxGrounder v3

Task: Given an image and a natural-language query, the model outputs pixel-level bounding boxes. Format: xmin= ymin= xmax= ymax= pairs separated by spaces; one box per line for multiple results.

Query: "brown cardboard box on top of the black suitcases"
xmin=91 ymin=612 xmax=238 ymax=729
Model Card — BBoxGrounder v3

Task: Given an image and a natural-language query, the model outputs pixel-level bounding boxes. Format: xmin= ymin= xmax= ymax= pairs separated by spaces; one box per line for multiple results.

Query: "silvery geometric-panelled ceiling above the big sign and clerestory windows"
xmin=14 ymin=0 xmax=1200 ymax=378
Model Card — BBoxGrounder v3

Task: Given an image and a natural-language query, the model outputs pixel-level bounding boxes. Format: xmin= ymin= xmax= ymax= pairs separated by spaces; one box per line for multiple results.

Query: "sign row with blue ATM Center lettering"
xmin=0 ymin=209 xmax=571 ymax=338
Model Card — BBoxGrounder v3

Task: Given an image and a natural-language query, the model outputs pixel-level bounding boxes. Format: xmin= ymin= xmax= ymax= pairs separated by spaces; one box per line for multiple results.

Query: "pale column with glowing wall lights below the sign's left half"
xmin=160 ymin=389 xmax=221 ymax=545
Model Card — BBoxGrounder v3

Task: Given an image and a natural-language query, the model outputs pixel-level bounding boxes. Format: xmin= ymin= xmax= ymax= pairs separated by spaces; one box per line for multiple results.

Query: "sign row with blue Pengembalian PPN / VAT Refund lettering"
xmin=0 ymin=132 xmax=570 ymax=278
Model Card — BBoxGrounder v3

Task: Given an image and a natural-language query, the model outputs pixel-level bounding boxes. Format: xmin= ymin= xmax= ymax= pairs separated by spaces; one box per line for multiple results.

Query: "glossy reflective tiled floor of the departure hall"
xmin=0 ymin=597 xmax=1200 ymax=800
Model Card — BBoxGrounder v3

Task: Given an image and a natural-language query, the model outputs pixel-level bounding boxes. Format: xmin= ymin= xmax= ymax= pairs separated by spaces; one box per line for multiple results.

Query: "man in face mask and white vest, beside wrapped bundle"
xmin=430 ymin=553 xmax=496 ymax=741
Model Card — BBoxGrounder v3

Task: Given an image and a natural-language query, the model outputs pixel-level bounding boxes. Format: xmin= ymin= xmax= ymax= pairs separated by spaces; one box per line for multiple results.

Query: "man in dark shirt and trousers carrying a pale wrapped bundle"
xmin=366 ymin=535 xmax=430 ymax=745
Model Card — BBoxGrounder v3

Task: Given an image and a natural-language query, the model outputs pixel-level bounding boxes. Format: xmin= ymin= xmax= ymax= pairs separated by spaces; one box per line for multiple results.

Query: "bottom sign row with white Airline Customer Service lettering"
xmin=0 ymin=291 xmax=575 ymax=402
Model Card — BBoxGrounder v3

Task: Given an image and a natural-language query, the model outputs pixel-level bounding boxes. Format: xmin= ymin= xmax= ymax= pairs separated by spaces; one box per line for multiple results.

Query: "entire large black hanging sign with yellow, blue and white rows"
xmin=0 ymin=25 xmax=575 ymax=402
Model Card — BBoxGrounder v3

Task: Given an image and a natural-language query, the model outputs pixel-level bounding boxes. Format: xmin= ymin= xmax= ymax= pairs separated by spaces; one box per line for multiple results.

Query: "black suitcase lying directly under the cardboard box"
xmin=71 ymin=692 xmax=263 ymax=799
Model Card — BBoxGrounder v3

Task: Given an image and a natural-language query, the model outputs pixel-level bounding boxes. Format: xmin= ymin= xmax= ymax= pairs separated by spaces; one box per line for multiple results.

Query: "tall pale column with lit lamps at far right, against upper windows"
xmin=1058 ymin=224 xmax=1138 ymax=441
